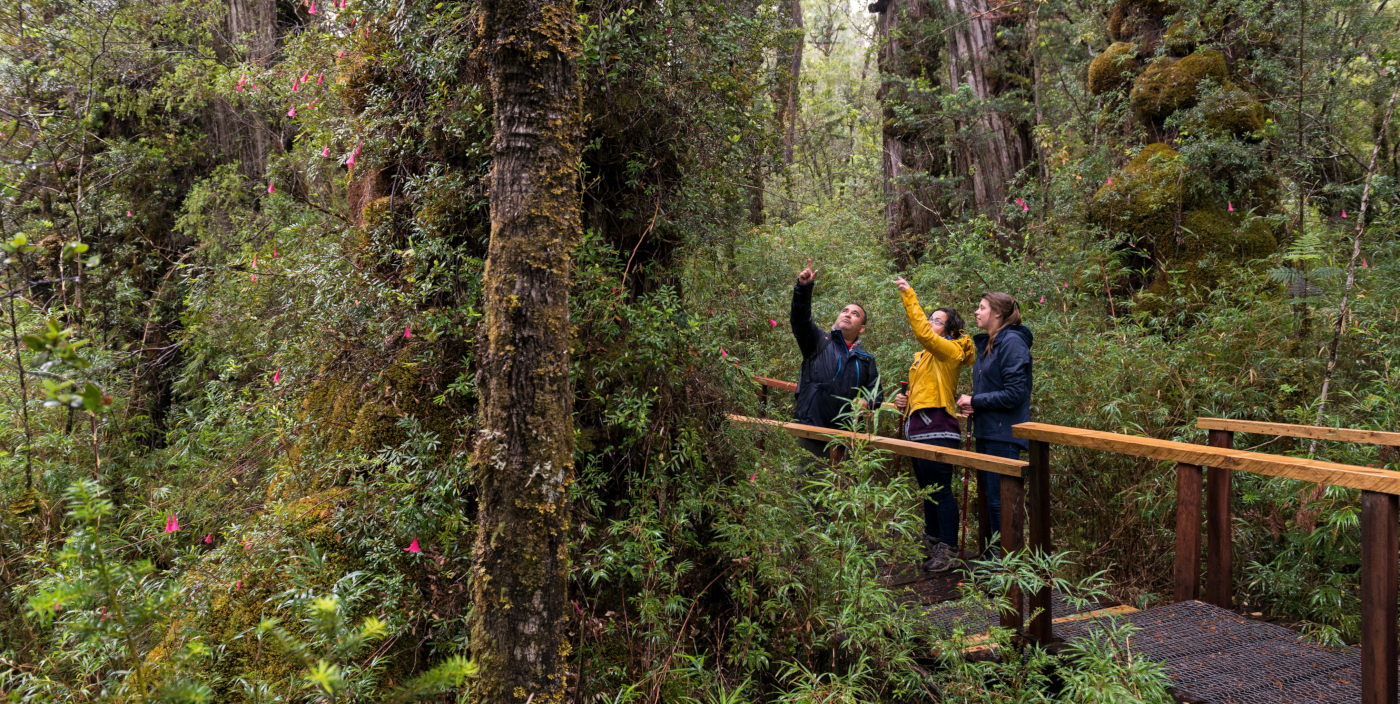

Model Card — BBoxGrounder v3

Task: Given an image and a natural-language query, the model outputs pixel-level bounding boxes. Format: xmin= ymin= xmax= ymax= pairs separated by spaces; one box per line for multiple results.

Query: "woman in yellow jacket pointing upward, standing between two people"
xmin=895 ymin=279 xmax=976 ymax=572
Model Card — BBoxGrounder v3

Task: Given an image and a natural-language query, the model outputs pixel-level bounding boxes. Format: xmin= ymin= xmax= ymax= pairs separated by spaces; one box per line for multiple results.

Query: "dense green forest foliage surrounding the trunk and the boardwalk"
xmin=0 ymin=0 xmax=1400 ymax=703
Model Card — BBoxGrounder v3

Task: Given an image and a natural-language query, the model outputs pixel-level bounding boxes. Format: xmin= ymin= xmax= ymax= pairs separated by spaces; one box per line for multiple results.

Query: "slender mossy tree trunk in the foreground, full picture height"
xmin=472 ymin=0 xmax=582 ymax=704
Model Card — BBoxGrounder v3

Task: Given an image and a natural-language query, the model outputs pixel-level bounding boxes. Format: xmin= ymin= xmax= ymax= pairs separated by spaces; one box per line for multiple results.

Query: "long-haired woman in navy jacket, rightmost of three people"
xmin=958 ymin=291 xmax=1035 ymax=545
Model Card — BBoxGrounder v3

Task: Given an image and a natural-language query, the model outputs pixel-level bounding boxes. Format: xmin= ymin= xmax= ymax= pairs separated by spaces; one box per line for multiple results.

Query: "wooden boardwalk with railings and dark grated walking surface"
xmin=731 ymin=379 xmax=1400 ymax=704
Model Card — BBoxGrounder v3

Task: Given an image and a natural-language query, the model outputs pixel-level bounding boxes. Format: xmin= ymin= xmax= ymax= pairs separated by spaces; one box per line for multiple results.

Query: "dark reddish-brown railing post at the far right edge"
xmin=1361 ymin=491 xmax=1400 ymax=704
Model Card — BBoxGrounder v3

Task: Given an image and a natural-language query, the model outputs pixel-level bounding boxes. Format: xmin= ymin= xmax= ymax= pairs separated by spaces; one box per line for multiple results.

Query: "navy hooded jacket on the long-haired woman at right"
xmin=972 ymin=325 xmax=1035 ymax=449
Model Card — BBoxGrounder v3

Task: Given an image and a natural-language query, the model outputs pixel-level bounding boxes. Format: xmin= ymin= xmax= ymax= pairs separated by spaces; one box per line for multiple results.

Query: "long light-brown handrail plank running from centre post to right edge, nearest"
xmin=1012 ymin=423 xmax=1400 ymax=494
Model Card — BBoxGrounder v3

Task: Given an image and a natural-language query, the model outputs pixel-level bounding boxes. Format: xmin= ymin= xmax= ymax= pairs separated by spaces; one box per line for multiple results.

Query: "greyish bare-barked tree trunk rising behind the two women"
xmin=945 ymin=0 xmax=1033 ymax=221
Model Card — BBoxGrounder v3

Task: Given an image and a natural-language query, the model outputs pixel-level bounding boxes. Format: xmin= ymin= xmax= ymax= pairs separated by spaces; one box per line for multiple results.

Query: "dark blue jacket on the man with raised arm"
xmin=791 ymin=284 xmax=883 ymax=428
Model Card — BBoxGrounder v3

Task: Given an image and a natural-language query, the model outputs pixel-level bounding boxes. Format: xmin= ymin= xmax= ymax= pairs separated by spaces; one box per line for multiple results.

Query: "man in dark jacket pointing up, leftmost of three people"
xmin=791 ymin=259 xmax=883 ymax=458
